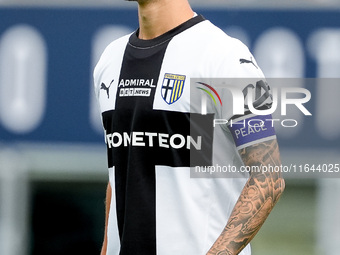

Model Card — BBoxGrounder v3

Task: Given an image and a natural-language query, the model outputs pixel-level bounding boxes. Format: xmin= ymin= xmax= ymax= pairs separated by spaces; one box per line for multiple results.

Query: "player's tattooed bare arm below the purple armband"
xmin=207 ymin=139 xmax=285 ymax=255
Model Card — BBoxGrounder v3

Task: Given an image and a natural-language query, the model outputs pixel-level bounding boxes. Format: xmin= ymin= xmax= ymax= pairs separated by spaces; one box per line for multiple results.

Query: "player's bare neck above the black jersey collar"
xmin=138 ymin=0 xmax=194 ymax=40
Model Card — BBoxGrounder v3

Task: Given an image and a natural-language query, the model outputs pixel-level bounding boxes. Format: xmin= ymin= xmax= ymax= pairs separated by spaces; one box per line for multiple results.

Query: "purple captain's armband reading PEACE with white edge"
xmin=228 ymin=115 xmax=276 ymax=150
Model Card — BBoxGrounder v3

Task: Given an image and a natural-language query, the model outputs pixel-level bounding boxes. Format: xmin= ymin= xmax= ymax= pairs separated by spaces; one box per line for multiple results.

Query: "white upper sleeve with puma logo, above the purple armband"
xmin=217 ymin=38 xmax=272 ymax=120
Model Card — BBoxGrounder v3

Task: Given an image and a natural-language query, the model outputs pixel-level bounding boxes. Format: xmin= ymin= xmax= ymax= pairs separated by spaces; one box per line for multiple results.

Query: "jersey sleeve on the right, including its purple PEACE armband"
xmin=217 ymin=37 xmax=276 ymax=150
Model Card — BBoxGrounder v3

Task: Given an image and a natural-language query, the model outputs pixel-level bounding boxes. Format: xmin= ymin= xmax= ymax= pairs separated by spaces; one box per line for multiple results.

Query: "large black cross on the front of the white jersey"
xmin=103 ymin=16 xmax=209 ymax=255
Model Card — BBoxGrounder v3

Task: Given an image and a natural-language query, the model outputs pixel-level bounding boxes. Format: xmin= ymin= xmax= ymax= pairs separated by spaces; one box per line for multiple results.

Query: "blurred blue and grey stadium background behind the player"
xmin=0 ymin=0 xmax=340 ymax=255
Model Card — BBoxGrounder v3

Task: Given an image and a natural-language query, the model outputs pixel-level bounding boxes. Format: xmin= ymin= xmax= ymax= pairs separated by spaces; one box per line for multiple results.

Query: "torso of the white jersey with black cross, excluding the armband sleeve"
xmin=94 ymin=15 xmax=263 ymax=255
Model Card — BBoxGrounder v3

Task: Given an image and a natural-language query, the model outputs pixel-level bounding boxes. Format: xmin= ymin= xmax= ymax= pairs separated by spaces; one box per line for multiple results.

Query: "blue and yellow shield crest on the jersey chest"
xmin=162 ymin=73 xmax=185 ymax=104
